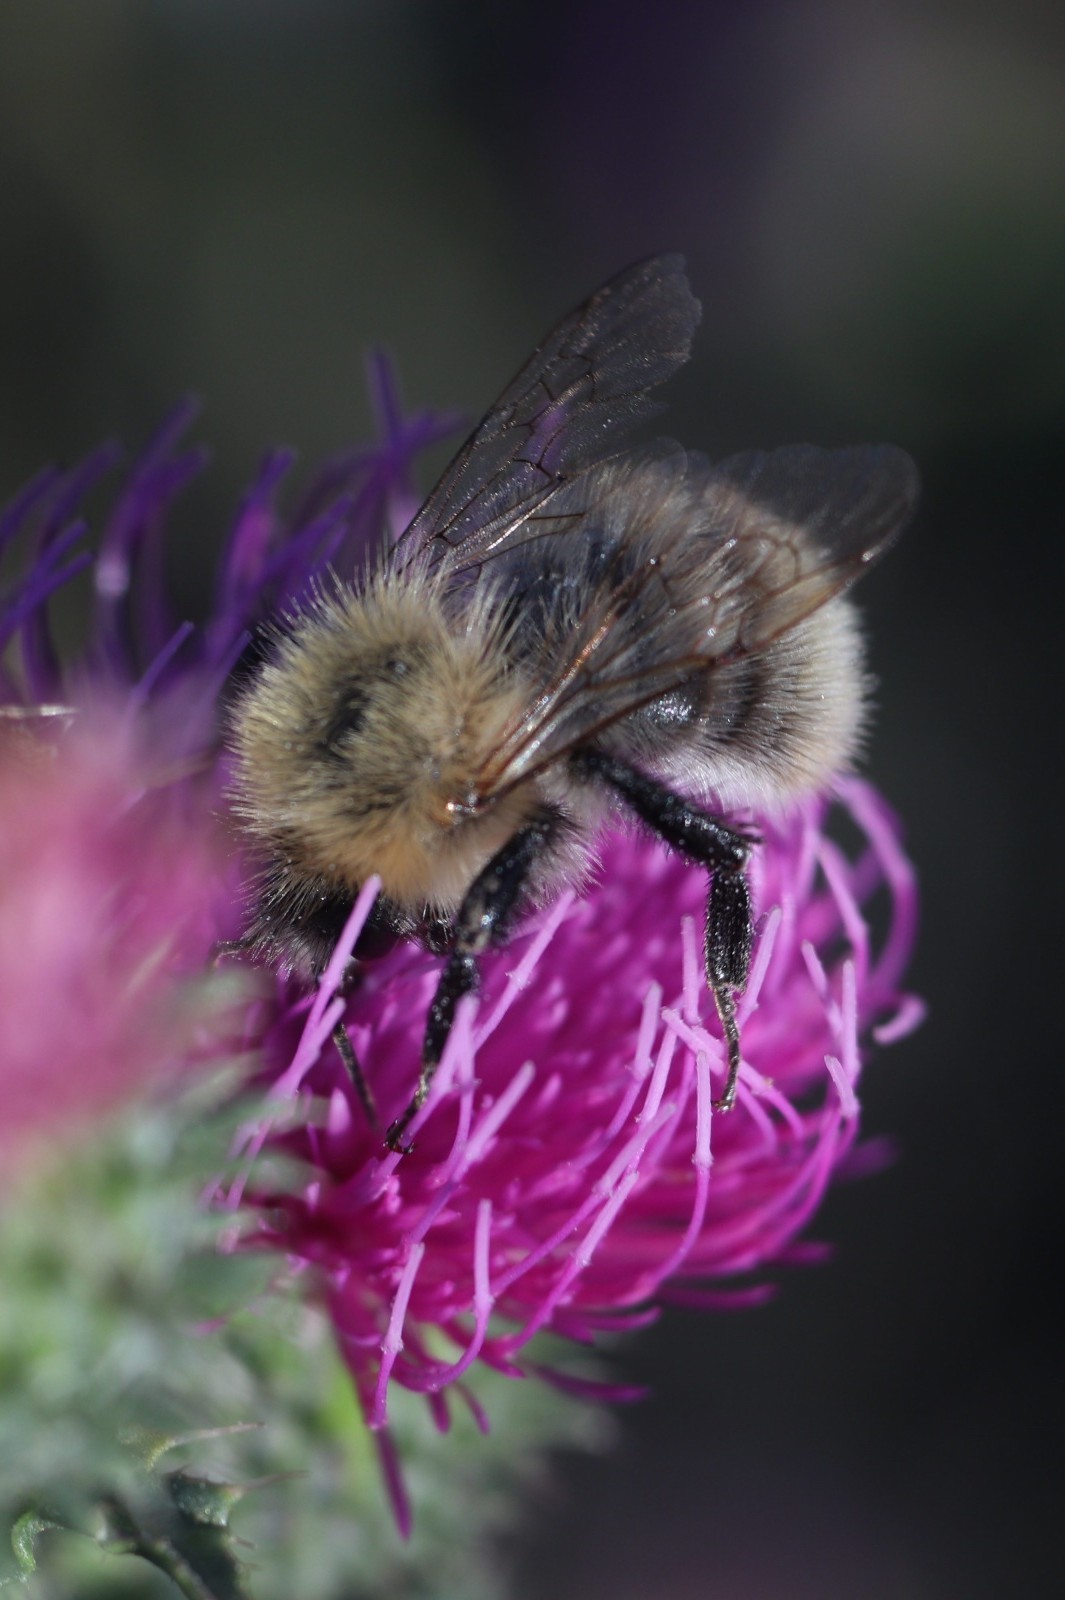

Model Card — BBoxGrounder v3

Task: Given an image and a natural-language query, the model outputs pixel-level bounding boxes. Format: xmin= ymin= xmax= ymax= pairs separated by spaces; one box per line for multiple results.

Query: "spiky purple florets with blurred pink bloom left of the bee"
xmin=0 ymin=360 xmax=453 ymax=1160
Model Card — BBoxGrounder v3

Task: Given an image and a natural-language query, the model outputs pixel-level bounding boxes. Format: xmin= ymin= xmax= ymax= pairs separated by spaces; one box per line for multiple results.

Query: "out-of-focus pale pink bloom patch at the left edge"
xmin=0 ymin=710 xmax=224 ymax=1170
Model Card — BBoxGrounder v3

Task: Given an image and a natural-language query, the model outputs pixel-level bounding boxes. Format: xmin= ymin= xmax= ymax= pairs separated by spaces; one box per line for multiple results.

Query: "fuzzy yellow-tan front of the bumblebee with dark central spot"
xmin=232 ymin=581 xmax=530 ymax=901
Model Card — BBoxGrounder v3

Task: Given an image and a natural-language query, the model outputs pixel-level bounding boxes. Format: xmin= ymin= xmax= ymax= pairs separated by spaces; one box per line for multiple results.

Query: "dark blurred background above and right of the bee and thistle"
xmin=0 ymin=0 xmax=1065 ymax=1600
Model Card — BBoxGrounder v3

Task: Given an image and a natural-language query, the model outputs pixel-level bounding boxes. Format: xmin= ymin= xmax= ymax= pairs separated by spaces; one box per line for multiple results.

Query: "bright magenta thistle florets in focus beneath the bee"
xmin=236 ymin=781 xmax=918 ymax=1452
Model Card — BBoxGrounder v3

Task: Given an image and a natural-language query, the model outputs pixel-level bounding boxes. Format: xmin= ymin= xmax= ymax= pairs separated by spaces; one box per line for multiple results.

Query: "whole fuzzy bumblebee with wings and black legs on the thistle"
xmin=232 ymin=256 xmax=916 ymax=1149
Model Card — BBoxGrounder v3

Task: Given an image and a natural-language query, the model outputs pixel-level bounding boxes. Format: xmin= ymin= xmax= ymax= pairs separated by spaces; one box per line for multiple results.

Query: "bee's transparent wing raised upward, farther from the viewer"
xmin=393 ymin=256 xmax=699 ymax=571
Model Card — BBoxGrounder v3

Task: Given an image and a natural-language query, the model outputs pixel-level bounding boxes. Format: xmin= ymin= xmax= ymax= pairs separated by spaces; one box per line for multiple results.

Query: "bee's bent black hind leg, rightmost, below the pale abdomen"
xmin=574 ymin=750 xmax=756 ymax=1110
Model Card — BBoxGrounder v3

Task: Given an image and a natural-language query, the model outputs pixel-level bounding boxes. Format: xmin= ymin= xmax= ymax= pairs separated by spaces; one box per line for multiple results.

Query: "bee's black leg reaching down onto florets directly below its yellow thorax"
xmin=385 ymin=813 xmax=558 ymax=1154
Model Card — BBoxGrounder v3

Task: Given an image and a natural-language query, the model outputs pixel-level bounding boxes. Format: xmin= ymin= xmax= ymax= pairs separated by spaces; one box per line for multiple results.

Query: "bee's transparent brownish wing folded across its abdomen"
xmin=478 ymin=445 xmax=918 ymax=797
